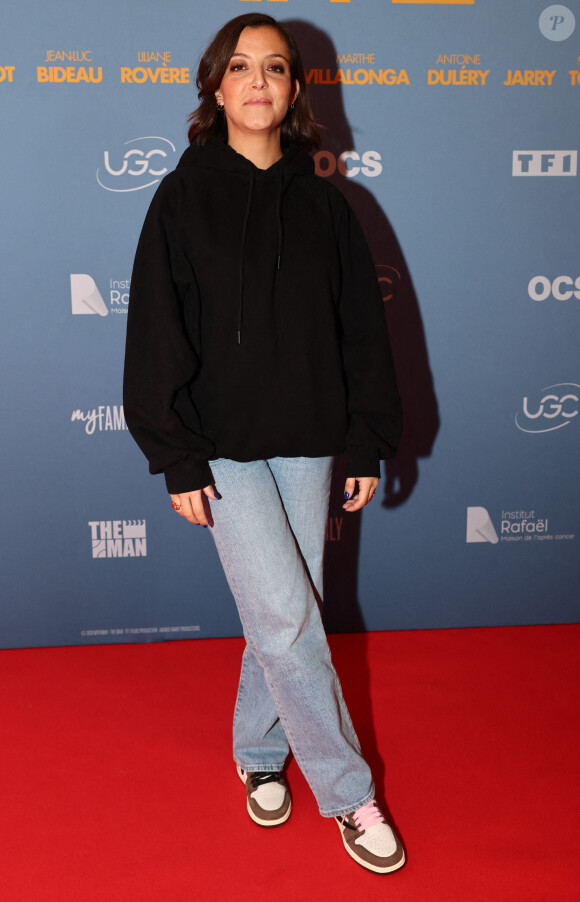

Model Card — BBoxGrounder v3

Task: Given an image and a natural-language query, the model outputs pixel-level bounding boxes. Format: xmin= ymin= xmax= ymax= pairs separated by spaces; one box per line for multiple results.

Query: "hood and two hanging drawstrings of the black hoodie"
xmin=177 ymin=138 xmax=314 ymax=344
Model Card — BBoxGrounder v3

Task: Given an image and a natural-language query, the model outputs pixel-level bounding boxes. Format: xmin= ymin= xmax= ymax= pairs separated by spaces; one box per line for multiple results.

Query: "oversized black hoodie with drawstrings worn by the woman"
xmin=124 ymin=138 xmax=401 ymax=493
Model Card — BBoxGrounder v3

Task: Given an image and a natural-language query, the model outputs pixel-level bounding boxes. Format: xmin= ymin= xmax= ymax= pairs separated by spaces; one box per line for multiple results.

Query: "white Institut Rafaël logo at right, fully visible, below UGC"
xmin=465 ymin=507 xmax=576 ymax=545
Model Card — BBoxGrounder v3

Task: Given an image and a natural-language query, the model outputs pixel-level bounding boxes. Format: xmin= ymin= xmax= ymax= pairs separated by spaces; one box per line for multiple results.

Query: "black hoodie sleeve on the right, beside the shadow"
xmin=338 ymin=203 xmax=402 ymax=476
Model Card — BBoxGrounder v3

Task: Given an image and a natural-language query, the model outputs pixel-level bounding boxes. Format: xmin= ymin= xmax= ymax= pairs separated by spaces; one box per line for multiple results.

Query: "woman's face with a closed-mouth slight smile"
xmin=215 ymin=27 xmax=299 ymax=141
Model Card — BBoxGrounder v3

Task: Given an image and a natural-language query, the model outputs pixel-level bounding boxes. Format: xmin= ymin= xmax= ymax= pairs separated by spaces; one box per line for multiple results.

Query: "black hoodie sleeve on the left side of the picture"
xmin=123 ymin=180 xmax=214 ymax=493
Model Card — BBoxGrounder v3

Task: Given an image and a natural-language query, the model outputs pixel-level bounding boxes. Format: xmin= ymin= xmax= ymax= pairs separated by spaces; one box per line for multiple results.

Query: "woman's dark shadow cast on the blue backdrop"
xmin=284 ymin=20 xmax=439 ymax=632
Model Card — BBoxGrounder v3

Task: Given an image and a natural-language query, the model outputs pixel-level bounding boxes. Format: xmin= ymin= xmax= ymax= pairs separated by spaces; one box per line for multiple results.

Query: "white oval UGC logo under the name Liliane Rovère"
xmin=97 ymin=135 xmax=175 ymax=192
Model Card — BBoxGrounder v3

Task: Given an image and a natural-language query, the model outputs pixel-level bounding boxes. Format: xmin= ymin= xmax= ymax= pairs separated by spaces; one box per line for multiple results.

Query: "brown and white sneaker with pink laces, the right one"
xmin=335 ymin=799 xmax=405 ymax=874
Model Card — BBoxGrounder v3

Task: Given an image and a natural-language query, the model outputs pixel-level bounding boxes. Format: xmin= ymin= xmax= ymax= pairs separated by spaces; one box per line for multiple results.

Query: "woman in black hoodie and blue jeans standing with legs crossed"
xmin=125 ymin=13 xmax=405 ymax=873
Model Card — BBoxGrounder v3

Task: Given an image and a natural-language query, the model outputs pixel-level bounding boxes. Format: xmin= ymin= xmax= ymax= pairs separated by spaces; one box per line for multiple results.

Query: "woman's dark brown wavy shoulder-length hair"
xmin=187 ymin=13 xmax=320 ymax=150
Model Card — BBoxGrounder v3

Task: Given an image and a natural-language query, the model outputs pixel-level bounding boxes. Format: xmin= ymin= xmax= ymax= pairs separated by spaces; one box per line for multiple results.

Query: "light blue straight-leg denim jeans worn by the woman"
xmin=211 ymin=457 xmax=374 ymax=817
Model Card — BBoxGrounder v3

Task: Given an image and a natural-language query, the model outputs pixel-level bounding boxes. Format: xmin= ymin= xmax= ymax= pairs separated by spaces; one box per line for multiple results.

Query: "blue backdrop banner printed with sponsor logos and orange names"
xmin=0 ymin=0 xmax=580 ymax=648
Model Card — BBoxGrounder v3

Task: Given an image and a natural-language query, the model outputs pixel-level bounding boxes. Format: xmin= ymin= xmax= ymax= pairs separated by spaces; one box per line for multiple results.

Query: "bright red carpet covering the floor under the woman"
xmin=0 ymin=626 xmax=580 ymax=902
